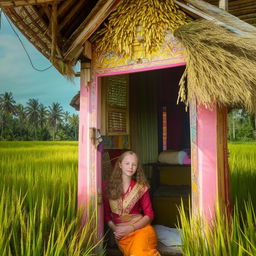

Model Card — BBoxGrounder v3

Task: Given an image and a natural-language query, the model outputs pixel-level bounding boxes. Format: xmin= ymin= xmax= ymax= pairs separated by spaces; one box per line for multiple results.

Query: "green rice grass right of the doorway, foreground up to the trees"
xmin=179 ymin=143 xmax=256 ymax=256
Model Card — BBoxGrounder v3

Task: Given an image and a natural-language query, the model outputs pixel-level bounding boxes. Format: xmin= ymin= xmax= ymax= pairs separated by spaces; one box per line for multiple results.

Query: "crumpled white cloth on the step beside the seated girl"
xmin=153 ymin=225 xmax=182 ymax=246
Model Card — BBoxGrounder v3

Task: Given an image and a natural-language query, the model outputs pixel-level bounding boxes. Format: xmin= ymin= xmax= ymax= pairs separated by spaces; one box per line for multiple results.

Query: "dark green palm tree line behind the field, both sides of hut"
xmin=0 ymin=92 xmax=256 ymax=141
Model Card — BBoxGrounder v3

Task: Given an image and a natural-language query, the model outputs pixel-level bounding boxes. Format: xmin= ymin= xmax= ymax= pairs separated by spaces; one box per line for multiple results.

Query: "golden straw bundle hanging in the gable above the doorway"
xmin=96 ymin=0 xmax=190 ymax=57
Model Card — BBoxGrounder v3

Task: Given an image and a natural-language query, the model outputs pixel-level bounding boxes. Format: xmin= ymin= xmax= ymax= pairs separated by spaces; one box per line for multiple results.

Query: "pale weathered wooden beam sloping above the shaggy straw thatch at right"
xmin=174 ymin=0 xmax=256 ymax=36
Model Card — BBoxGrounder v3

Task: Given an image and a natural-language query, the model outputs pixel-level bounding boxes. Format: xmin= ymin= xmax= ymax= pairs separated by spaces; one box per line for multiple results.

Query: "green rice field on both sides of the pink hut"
xmin=0 ymin=142 xmax=256 ymax=256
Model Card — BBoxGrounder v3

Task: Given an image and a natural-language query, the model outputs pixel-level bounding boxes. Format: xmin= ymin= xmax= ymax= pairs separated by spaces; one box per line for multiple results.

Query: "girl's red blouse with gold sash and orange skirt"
xmin=103 ymin=180 xmax=160 ymax=256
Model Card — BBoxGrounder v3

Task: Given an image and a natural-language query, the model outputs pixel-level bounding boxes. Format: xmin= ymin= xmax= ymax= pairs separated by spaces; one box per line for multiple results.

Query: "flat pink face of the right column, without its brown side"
xmin=197 ymin=105 xmax=218 ymax=220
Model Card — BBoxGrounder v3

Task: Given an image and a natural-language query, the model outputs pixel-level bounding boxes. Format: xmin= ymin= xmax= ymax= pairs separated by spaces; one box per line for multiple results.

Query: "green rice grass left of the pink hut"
xmin=0 ymin=142 xmax=103 ymax=256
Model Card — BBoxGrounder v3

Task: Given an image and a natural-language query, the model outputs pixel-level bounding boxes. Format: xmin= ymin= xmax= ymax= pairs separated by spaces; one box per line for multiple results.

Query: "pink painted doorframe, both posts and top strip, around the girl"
xmin=78 ymin=61 xmax=230 ymax=237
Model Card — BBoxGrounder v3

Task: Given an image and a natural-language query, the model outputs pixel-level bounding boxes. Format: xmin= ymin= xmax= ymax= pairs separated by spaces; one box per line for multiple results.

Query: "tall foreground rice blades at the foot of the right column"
xmin=179 ymin=202 xmax=256 ymax=256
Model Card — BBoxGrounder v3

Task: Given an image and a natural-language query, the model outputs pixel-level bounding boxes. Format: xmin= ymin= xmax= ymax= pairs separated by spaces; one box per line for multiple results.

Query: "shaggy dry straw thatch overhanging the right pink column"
xmin=174 ymin=20 xmax=256 ymax=113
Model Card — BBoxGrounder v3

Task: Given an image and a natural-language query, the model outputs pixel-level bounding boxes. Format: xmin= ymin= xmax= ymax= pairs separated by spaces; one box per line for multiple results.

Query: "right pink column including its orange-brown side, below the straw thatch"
xmin=191 ymin=105 xmax=229 ymax=221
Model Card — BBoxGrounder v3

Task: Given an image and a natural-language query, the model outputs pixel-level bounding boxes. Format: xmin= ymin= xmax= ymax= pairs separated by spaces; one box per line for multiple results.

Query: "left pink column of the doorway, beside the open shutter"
xmin=78 ymin=64 xmax=103 ymax=241
